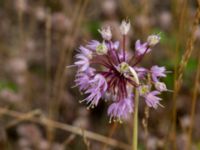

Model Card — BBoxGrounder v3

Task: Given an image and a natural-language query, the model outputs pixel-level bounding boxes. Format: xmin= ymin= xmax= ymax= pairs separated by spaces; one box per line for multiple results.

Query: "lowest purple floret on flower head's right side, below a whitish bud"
xmin=144 ymin=91 xmax=162 ymax=109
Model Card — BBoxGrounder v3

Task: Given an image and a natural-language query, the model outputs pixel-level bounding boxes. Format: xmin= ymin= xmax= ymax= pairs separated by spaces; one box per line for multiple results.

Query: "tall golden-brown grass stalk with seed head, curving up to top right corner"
xmin=171 ymin=2 xmax=200 ymax=150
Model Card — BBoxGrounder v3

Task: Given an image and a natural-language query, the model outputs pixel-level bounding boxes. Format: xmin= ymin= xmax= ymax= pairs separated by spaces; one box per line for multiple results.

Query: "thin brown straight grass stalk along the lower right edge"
xmin=186 ymin=53 xmax=200 ymax=150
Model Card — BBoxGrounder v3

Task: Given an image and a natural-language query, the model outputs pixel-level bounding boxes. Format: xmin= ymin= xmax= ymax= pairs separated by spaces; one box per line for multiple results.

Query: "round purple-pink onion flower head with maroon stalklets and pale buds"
xmin=74 ymin=21 xmax=167 ymax=122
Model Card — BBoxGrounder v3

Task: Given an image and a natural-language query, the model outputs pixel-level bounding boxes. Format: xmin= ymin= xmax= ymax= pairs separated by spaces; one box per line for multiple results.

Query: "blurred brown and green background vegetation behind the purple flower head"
xmin=0 ymin=0 xmax=200 ymax=150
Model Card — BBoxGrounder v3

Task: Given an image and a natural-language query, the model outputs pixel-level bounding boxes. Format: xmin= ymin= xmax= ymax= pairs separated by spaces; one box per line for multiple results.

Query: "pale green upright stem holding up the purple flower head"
xmin=132 ymin=88 xmax=139 ymax=150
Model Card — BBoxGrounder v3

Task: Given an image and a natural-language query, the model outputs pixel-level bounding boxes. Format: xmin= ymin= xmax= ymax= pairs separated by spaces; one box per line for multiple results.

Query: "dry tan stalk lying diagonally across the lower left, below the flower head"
xmin=0 ymin=108 xmax=131 ymax=150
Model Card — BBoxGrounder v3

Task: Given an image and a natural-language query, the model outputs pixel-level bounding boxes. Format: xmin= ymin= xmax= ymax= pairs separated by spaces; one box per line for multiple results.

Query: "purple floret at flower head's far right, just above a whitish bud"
xmin=150 ymin=65 xmax=166 ymax=82
